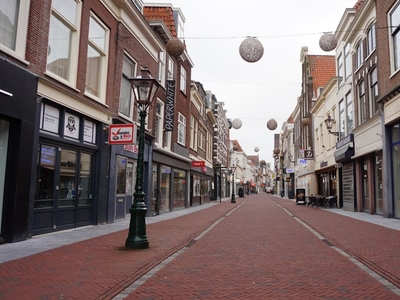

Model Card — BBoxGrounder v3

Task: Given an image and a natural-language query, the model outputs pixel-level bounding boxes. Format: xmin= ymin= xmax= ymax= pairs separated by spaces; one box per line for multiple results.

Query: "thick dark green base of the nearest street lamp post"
xmin=125 ymin=202 xmax=149 ymax=249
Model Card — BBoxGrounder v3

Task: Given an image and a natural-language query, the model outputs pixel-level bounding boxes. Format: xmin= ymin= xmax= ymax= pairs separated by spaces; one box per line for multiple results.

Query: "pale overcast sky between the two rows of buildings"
xmin=145 ymin=0 xmax=357 ymax=163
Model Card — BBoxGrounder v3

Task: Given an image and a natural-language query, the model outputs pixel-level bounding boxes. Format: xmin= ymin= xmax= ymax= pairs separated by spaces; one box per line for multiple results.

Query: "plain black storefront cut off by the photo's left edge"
xmin=0 ymin=58 xmax=40 ymax=242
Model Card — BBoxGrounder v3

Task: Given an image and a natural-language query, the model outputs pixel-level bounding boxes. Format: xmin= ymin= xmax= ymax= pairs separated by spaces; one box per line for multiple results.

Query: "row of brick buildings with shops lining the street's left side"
xmin=0 ymin=0 xmax=257 ymax=242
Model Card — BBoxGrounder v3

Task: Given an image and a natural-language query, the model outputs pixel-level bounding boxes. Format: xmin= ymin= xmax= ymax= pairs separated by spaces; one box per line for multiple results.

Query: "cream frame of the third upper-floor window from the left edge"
xmin=85 ymin=12 xmax=110 ymax=104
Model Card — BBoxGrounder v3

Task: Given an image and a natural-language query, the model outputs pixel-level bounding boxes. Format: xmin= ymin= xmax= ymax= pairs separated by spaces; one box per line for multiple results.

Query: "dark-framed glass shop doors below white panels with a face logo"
xmin=33 ymin=144 xmax=94 ymax=235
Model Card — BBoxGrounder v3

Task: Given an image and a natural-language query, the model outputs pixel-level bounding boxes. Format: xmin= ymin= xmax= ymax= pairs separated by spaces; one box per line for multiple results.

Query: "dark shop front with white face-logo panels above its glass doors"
xmin=32 ymin=97 xmax=108 ymax=235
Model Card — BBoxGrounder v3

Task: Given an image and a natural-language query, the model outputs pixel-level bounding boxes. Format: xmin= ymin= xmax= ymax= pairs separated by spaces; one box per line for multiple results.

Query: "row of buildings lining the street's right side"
xmin=274 ymin=0 xmax=400 ymax=218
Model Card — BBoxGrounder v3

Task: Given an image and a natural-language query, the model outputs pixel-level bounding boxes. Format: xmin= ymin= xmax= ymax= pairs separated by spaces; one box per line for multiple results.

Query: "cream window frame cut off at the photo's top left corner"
xmin=0 ymin=0 xmax=31 ymax=64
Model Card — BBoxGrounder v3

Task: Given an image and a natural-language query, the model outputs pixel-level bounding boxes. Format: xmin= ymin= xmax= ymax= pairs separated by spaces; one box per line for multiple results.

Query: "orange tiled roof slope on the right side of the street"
xmin=308 ymin=55 xmax=336 ymax=95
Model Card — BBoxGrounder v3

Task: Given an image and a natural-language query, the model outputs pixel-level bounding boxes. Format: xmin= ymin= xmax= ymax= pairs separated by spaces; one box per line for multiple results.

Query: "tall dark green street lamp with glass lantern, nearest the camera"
xmin=125 ymin=67 xmax=159 ymax=249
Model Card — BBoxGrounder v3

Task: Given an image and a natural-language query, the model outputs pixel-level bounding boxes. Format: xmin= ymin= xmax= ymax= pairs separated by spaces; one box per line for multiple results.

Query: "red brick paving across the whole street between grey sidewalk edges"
xmin=0 ymin=194 xmax=400 ymax=299
